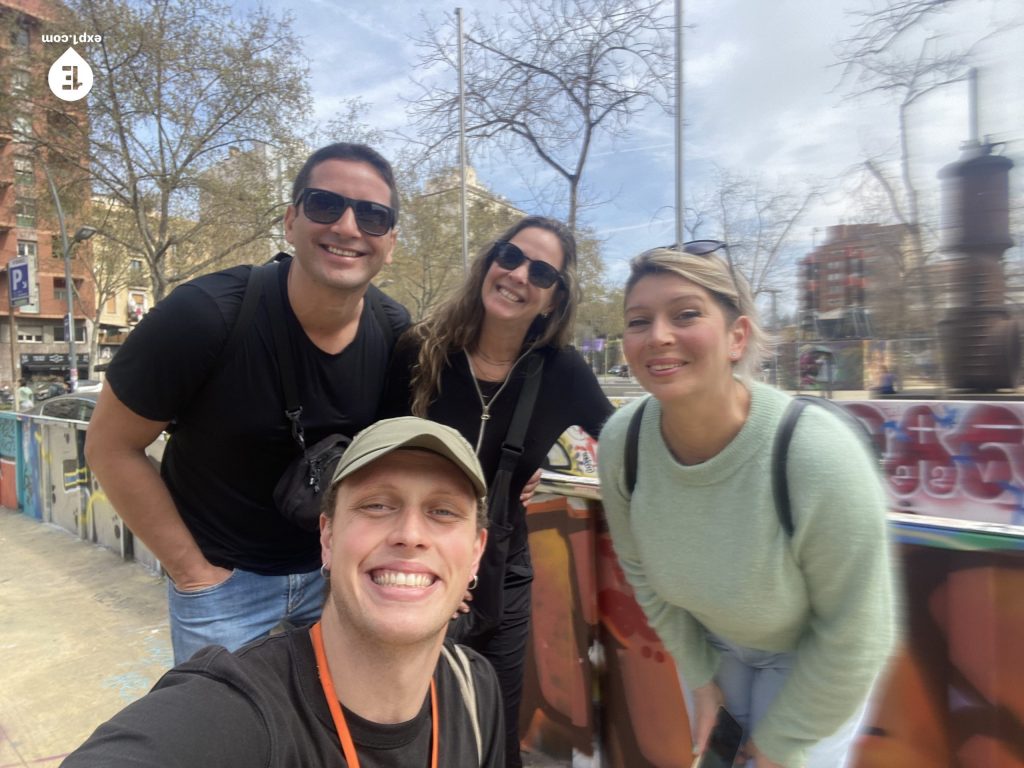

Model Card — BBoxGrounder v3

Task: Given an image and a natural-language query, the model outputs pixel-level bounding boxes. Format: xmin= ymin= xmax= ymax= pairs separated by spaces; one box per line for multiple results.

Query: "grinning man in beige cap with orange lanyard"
xmin=63 ymin=417 xmax=505 ymax=768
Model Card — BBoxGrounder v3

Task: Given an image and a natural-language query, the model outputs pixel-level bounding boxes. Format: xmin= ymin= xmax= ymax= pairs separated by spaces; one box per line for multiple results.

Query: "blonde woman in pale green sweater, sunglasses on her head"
xmin=599 ymin=246 xmax=895 ymax=768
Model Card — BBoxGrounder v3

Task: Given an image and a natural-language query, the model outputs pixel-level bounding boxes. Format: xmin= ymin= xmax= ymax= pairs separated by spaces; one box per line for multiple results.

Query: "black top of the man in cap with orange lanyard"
xmin=62 ymin=630 xmax=505 ymax=768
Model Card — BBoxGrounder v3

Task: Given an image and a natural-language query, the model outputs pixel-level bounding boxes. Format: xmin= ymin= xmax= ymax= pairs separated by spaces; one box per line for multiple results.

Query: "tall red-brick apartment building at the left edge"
xmin=0 ymin=0 xmax=94 ymax=387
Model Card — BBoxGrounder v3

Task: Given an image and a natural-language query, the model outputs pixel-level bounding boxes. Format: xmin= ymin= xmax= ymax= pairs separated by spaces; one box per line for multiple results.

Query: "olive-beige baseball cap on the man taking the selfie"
xmin=331 ymin=416 xmax=487 ymax=497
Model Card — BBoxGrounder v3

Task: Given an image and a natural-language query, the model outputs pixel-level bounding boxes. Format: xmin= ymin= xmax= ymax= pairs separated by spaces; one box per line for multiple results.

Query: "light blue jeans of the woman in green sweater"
xmin=679 ymin=632 xmax=867 ymax=768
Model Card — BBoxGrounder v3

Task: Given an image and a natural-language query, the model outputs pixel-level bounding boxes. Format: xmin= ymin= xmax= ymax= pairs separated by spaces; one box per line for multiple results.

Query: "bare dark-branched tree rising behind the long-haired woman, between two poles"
xmin=403 ymin=0 xmax=673 ymax=229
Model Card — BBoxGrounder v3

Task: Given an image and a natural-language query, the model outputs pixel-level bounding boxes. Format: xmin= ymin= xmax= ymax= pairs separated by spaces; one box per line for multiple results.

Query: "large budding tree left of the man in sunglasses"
xmin=30 ymin=0 xmax=309 ymax=299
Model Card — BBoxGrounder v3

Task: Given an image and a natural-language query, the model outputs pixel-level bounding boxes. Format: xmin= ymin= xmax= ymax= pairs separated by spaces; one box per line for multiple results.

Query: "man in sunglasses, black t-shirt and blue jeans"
xmin=86 ymin=143 xmax=409 ymax=663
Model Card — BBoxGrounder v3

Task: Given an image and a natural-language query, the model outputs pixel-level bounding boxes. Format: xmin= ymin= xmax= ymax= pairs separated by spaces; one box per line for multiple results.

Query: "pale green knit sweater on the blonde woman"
xmin=599 ymin=383 xmax=895 ymax=768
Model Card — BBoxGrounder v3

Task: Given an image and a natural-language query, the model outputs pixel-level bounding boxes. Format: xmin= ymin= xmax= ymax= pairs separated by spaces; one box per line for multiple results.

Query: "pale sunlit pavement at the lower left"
xmin=0 ymin=508 xmax=172 ymax=768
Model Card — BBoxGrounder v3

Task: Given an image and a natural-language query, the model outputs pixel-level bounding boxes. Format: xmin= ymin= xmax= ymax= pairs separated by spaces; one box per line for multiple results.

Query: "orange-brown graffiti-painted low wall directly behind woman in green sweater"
xmin=520 ymin=496 xmax=1024 ymax=768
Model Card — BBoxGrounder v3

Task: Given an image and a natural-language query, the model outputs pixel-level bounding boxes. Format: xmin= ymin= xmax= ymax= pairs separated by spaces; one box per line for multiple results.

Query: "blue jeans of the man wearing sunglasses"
xmin=167 ymin=568 xmax=325 ymax=665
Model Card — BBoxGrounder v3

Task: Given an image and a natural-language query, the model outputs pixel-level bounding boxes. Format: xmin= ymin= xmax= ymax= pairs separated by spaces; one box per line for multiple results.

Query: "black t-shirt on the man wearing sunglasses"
xmin=106 ymin=259 xmax=409 ymax=574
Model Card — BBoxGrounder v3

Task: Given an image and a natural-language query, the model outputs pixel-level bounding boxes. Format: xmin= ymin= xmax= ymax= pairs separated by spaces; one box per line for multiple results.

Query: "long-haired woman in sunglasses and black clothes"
xmin=384 ymin=216 xmax=612 ymax=766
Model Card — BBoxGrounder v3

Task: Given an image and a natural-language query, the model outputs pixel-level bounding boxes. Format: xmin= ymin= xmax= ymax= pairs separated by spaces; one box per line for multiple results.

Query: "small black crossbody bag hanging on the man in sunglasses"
xmin=273 ymin=434 xmax=352 ymax=532
